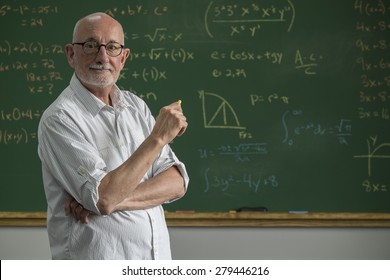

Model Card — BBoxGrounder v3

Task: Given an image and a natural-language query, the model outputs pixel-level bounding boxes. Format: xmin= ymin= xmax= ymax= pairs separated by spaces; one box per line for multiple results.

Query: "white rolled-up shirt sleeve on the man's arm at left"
xmin=38 ymin=112 xmax=107 ymax=213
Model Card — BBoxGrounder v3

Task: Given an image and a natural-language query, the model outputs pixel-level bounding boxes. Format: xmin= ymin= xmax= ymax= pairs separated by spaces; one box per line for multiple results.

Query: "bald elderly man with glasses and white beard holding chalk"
xmin=38 ymin=13 xmax=189 ymax=259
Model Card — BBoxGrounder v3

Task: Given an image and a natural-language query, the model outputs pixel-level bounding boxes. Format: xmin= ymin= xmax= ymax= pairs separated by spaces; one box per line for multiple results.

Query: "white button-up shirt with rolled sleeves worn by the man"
xmin=38 ymin=75 xmax=189 ymax=259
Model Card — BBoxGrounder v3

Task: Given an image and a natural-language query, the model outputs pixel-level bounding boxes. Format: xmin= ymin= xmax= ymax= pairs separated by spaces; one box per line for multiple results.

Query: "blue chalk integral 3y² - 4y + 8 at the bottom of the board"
xmin=203 ymin=168 xmax=279 ymax=196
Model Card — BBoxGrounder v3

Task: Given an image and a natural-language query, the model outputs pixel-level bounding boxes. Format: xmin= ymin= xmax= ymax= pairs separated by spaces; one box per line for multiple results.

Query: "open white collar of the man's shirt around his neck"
xmin=70 ymin=74 xmax=130 ymax=116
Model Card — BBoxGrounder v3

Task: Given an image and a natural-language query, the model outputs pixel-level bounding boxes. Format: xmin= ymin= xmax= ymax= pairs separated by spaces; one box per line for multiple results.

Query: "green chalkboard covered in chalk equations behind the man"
xmin=0 ymin=0 xmax=390 ymax=213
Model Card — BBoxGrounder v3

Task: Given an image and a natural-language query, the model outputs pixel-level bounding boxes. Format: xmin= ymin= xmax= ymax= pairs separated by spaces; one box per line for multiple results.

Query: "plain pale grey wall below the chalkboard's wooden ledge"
xmin=0 ymin=227 xmax=390 ymax=259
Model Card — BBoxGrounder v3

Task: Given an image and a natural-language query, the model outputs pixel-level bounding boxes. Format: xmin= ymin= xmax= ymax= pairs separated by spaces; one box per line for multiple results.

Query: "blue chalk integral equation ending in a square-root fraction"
xmin=282 ymin=110 xmax=352 ymax=146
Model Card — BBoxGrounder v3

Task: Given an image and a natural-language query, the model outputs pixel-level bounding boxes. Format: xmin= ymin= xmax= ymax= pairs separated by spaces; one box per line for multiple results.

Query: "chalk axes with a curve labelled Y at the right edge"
xmin=354 ymin=136 xmax=390 ymax=177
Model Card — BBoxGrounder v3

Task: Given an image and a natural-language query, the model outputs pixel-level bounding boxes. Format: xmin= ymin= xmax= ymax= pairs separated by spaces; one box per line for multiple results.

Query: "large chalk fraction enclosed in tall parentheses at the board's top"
xmin=204 ymin=0 xmax=295 ymax=38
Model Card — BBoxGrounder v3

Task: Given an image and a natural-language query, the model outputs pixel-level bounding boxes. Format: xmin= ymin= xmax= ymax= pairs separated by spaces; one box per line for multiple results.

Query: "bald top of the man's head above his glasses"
xmin=73 ymin=13 xmax=124 ymax=44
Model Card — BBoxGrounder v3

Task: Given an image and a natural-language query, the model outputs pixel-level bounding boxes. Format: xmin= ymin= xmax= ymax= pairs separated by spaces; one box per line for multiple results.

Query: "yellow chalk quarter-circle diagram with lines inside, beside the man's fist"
xmin=199 ymin=90 xmax=245 ymax=129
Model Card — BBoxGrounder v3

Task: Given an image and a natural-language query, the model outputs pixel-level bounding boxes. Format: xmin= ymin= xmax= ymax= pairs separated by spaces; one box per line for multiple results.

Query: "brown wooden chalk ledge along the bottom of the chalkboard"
xmin=0 ymin=212 xmax=390 ymax=227
